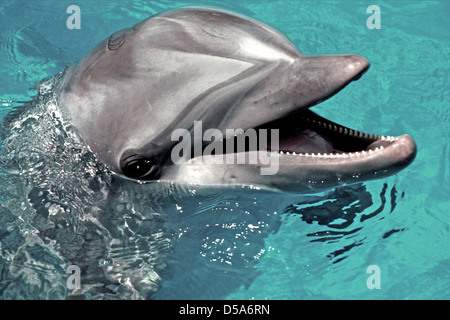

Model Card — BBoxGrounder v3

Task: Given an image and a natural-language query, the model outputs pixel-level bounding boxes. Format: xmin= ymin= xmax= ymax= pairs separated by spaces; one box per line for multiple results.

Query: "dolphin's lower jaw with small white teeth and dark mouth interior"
xmin=162 ymin=110 xmax=417 ymax=192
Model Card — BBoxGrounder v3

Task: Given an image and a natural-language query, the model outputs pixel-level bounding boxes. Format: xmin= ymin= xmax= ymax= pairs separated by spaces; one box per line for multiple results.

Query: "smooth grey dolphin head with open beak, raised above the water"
xmin=60 ymin=7 xmax=416 ymax=192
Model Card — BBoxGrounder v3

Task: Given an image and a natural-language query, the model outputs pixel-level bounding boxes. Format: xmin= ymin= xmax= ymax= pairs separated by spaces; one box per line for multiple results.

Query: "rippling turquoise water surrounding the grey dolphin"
xmin=0 ymin=0 xmax=450 ymax=299
